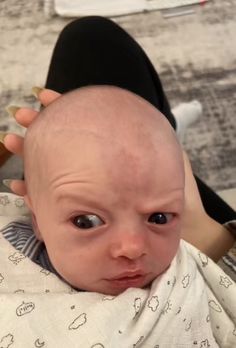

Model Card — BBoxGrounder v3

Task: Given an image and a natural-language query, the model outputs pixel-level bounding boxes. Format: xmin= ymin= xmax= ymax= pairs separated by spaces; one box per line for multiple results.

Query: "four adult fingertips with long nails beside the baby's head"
xmin=4 ymin=89 xmax=60 ymax=196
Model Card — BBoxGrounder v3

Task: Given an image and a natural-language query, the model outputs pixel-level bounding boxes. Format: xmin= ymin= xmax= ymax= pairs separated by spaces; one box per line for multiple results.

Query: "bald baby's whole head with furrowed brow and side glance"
xmin=22 ymin=86 xmax=184 ymax=295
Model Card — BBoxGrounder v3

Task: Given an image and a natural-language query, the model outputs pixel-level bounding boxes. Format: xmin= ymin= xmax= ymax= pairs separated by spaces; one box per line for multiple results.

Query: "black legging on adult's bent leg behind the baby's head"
xmin=46 ymin=16 xmax=236 ymax=223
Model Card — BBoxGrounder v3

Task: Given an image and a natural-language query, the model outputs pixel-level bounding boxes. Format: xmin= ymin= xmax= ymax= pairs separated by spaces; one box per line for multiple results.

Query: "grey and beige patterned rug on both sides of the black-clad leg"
xmin=0 ymin=0 xmax=236 ymax=208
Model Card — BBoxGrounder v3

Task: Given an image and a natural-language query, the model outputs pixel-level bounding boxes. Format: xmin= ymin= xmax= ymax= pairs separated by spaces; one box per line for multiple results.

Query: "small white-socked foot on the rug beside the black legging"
xmin=171 ymin=100 xmax=202 ymax=142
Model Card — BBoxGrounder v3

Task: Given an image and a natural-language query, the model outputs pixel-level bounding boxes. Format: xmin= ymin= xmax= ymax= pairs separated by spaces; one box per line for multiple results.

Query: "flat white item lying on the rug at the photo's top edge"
xmin=48 ymin=0 xmax=208 ymax=17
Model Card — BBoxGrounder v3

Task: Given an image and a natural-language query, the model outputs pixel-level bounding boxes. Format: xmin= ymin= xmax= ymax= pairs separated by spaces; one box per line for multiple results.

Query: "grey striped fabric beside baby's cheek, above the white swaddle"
xmin=1 ymin=221 xmax=57 ymax=278
